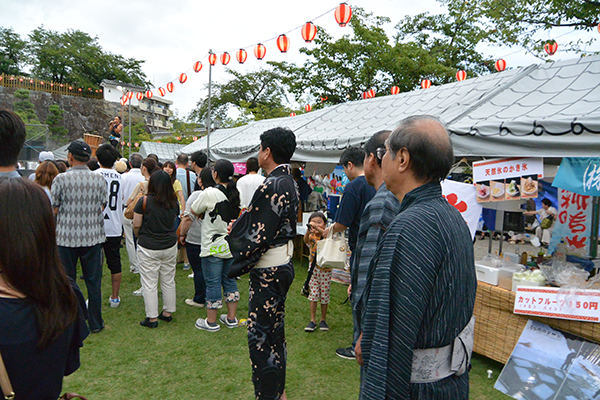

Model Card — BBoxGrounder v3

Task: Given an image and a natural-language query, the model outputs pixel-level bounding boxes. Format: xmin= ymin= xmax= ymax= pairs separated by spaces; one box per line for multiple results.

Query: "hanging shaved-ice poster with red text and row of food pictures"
xmin=473 ymin=157 xmax=544 ymax=203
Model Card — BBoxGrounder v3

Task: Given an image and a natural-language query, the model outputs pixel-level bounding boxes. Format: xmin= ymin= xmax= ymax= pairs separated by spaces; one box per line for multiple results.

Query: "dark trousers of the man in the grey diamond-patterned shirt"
xmin=58 ymin=244 xmax=104 ymax=332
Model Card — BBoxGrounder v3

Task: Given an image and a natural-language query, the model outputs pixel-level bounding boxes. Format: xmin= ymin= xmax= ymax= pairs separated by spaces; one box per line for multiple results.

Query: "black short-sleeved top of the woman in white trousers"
xmin=133 ymin=194 xmax=179 ymax=250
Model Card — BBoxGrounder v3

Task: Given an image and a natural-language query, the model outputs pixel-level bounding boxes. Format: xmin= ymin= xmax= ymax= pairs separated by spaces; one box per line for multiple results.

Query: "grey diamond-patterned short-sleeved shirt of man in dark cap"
xmin=51 ymin=165 xmax=108 ymax=247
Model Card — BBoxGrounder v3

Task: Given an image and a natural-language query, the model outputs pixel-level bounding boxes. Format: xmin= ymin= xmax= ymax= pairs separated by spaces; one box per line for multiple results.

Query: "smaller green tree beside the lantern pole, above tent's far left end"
xmin=189 ymin=68 xmax=290 ymax=126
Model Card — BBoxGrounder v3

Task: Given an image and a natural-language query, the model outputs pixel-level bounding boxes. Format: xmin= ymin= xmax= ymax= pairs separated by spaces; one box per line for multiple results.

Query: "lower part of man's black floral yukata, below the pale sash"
xmin=248 ymin=261 xmax=294 ymax=400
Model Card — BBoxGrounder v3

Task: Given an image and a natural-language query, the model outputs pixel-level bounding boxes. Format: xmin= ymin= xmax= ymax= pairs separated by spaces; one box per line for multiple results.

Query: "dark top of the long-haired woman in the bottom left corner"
xmin=0 ymin=298 xmax=88 ymax=400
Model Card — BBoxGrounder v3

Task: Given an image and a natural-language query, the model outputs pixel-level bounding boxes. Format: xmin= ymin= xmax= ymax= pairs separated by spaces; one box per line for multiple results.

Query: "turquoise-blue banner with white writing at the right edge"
xmin=552 ymin=157 xmax=600 ymax=196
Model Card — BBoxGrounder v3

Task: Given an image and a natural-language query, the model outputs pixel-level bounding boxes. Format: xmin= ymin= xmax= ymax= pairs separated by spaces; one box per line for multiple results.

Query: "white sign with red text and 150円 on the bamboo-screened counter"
xmin=514 ymin=286 xmax=600 ymax=322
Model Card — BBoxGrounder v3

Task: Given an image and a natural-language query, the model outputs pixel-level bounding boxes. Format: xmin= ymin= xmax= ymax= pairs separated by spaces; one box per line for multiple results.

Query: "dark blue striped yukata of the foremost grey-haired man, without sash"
xmin=360 ymin=183 xmax=477 ymax=400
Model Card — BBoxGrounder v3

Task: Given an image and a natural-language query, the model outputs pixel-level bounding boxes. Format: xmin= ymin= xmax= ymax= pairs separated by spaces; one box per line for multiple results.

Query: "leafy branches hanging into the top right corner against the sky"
xmin=439 ymin=0 xmax=600 ymax=57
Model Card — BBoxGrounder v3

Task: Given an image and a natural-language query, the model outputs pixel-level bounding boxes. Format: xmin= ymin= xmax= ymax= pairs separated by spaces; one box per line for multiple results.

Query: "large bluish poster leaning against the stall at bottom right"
xmin=494 ymin=320 xmax=600 ymax=400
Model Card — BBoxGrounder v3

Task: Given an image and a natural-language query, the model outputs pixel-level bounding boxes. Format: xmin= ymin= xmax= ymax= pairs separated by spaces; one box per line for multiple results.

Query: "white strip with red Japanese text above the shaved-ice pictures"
xmin=473 ymin=157 xmax=544 ymax=183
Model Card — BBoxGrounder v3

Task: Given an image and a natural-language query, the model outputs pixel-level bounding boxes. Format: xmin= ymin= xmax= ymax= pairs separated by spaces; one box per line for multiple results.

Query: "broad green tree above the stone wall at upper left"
xmin=28 ymin=26 xmax=148 ymax=87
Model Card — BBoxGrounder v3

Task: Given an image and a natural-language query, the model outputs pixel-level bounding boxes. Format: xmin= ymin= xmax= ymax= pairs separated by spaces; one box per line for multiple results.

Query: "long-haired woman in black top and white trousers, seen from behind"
xmin=133 ymin=170 xmax=179 ymax=328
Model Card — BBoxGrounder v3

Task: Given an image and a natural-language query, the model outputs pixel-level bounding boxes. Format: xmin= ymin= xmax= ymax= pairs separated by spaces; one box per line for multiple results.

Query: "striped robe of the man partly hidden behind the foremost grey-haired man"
xmin=350 ymin=183 xmax=400 ymax=304
